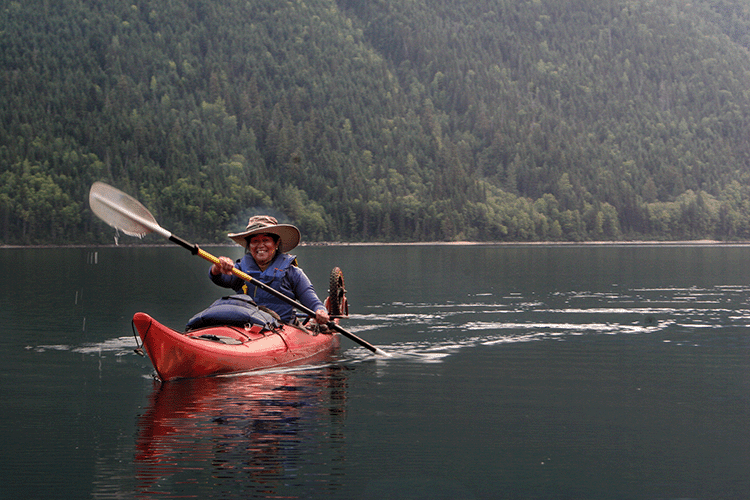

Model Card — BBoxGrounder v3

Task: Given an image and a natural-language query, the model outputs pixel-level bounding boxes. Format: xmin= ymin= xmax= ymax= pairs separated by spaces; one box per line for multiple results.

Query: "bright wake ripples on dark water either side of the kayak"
xmin=27 ymin=286 xmax=750 ymax=370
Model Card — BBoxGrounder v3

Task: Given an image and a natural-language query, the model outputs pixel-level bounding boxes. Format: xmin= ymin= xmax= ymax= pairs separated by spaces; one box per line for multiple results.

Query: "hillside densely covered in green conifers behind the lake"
xmin=0 ymin=0 xmax=750 ymax=244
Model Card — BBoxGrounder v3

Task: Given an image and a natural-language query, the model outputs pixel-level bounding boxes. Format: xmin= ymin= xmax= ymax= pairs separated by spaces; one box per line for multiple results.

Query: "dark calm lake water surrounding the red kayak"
xmin=0 ymin=245 xmax=750 ymax=499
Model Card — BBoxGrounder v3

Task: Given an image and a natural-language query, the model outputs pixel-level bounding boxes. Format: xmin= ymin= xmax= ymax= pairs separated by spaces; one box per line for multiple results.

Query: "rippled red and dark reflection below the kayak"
xmin=135 ymin=366 xmax=346 ymax=498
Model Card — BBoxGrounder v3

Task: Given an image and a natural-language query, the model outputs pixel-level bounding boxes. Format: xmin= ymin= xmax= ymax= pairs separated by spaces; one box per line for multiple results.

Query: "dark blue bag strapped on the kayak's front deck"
xmin=185 ymin=294 xmax=281 ymax=331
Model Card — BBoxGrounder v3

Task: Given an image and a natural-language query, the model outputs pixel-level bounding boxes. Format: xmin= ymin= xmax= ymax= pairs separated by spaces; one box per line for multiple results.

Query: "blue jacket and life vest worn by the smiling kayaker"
xmin=208 ymin=253 xmax=325 ymax=323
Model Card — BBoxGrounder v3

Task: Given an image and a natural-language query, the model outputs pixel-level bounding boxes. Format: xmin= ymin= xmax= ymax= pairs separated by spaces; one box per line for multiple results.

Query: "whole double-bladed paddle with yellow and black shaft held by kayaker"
xmin=89 ymin=182 xmax=388 ymax=356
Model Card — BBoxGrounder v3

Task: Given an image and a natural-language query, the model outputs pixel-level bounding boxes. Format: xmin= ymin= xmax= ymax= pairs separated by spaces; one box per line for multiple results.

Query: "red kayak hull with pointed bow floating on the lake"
xmin=133 ymin=312 xmax=339 ymax=381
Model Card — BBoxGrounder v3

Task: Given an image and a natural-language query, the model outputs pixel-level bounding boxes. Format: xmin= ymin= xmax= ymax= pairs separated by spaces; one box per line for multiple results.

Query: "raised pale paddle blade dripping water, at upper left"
xmin=89 ymin=182 xmax=159 ymax=238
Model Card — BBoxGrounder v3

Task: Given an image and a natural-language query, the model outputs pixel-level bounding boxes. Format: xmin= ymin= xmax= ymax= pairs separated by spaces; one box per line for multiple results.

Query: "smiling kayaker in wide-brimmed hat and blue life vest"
xmin=210 ymin=215 xmax=330 ymax=325
